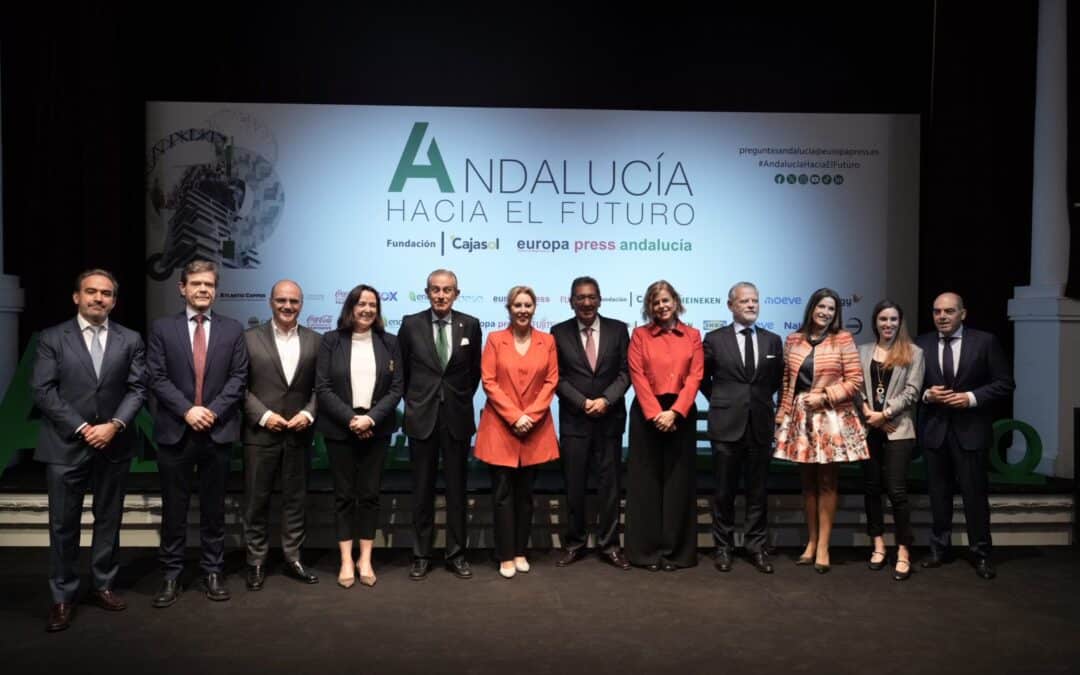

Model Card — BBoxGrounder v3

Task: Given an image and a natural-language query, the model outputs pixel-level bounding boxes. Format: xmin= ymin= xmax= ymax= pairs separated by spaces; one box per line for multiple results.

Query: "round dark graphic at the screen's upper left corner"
xmin=146 ymin=109 xmax=285 ymax=281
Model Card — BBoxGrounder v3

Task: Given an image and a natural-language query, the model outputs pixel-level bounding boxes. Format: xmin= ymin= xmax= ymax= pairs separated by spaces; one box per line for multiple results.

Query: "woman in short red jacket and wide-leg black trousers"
xmin=625 ymin=281 xmax=705 ymax=571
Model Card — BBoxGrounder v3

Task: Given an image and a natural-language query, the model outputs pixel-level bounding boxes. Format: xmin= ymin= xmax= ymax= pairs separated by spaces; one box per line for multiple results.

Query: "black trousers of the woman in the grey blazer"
xmin=863 ymin=429 xmax=915 ymax=546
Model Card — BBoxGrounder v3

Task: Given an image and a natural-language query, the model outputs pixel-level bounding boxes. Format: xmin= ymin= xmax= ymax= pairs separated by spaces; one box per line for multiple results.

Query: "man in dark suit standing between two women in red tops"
xmin=551 ymin=276 xmax=630 ymax=569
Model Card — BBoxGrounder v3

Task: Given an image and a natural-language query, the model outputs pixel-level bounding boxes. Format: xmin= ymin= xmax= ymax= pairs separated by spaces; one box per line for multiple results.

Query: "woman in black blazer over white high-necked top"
xmin=315 ymin=284 xmax=404 ymax=589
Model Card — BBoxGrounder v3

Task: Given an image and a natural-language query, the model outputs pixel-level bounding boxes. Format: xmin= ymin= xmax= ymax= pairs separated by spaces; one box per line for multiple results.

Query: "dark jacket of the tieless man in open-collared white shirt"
xmin=244 ymin=321 xmax=322 ymax=447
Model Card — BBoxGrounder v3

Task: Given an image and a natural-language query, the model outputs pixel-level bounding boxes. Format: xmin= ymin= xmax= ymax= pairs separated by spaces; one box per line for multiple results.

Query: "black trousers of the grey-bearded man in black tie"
xmin=713 ymin=427 xmax=772 ymax=553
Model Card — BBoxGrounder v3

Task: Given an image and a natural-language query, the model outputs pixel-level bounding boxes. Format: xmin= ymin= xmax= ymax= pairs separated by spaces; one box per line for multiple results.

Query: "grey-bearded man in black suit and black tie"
xmin=701 ymin=281 xmax=784 ymax=575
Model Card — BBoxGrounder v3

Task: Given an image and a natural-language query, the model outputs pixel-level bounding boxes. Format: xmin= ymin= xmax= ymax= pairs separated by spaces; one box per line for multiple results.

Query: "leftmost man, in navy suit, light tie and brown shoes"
xmin=30 ymin=269 xmax=146 ymax=632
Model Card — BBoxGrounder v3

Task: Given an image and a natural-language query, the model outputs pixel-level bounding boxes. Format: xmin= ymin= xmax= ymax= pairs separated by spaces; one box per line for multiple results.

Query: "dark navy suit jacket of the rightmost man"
xmin=915 ymin=326 xmax=1016 ymax=450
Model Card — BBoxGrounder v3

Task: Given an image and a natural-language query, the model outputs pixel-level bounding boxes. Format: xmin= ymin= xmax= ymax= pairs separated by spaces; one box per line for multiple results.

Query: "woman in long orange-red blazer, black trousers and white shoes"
xmin=476 ymin=286 xmax=558 ymax=579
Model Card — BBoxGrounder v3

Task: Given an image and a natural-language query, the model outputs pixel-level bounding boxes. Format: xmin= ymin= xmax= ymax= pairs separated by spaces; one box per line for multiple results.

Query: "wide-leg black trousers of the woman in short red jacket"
xmin=626 ymin=395 xmax=698 ymax=567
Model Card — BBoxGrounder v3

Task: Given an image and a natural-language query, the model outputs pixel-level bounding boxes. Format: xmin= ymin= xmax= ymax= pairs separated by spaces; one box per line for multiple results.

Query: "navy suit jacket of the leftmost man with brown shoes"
xmin=30 ymin=319 xmax=146 ymax=464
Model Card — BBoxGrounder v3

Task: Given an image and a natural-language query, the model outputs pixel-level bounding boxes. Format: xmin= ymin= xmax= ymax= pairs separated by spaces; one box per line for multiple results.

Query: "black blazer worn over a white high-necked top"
xmin=315 ymin=328 xmax=404 ymax=441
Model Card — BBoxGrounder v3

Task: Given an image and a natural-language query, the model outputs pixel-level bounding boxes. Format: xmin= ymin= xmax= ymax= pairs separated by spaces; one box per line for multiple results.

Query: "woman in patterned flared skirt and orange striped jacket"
xmin=774 ymin=288 xmax=869 ymax=573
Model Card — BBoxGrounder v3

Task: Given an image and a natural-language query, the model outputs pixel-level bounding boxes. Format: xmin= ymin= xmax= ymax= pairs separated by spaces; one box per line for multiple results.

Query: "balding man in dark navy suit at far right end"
xmin=916 ymin=293 xmax=1015 ymax=579
